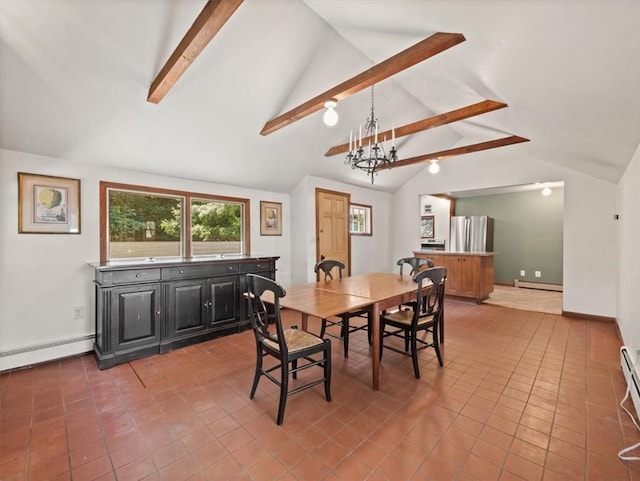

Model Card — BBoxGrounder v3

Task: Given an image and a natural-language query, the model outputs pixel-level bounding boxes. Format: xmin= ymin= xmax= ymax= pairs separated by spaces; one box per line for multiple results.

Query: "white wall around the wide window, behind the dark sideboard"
xmin=0 ymin=150 xmax=291 ymax=370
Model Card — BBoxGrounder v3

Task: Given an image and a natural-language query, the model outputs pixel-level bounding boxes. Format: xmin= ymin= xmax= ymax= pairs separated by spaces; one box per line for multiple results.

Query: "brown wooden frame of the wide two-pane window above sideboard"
xmin=100 ymin=181 xmax=251 ymax=264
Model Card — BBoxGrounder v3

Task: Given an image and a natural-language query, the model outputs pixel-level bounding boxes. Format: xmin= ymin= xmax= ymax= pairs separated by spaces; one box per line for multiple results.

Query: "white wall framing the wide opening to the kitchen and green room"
xmin=391 ymin=154 xmax=620 ymax=317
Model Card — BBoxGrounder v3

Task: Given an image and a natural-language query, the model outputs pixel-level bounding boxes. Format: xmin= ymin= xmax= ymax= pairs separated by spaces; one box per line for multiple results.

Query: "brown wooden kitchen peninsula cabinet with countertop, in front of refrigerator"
xmin=414 ymin=251 xmax=494 ymax=302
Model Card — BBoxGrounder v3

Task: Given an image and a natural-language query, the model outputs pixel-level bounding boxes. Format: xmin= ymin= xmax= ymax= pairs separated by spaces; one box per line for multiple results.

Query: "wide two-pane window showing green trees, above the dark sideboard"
xmin=100 ymin=182 xmax=249 ymax=262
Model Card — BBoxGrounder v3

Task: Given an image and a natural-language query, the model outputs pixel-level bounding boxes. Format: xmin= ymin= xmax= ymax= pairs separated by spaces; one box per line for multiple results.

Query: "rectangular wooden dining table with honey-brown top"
xmin=267 ymin=272 xmax=424 ymax=391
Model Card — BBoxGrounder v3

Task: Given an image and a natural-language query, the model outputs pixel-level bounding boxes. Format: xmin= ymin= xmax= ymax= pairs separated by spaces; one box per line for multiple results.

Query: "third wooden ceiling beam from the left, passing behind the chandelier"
xmin=324 ymin=100 xmax=507 ymax=157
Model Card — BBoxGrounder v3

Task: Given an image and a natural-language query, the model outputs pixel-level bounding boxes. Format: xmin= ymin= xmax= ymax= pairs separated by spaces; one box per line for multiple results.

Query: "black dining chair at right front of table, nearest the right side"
xmin=380 ymin=267 xmax=447 ymax=379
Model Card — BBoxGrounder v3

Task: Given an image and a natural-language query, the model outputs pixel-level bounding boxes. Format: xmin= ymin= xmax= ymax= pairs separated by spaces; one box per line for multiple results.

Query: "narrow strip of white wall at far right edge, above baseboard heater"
xmin=616 ymin=146 xmax=640 ymax=349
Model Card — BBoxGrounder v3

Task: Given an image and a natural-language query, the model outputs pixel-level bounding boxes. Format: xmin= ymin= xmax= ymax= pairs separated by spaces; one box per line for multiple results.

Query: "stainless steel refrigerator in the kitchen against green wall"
xmin=449 ymin=215 xmax=493 ymax=252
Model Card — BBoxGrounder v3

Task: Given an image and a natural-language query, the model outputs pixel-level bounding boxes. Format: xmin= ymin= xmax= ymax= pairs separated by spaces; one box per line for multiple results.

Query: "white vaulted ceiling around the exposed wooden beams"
xmin=0 ymin=0 xmax=640 ymax=192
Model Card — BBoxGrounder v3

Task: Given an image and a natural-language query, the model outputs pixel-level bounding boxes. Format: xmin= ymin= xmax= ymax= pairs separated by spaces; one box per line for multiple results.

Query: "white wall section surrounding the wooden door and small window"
xmin=291 ymin=176 xmax=392 ymax=284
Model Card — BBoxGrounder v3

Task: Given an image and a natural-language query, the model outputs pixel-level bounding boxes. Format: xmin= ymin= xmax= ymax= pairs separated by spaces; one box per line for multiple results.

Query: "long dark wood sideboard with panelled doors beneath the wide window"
xmin=93 ymin=256 xmax=279 ymax=369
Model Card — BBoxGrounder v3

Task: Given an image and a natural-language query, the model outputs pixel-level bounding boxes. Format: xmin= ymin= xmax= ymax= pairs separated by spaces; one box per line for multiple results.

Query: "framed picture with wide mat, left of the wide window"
xmin=18 ymin=172 xmax=80 ymax=234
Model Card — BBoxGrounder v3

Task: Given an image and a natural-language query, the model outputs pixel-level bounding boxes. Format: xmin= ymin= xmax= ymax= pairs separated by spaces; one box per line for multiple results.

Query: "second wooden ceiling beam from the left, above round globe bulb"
xmin=260 ymin=32 xmax=465 ymax=135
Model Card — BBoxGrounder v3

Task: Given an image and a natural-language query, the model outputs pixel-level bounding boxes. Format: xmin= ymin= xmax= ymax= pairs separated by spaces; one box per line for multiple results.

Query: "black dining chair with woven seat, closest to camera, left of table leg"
xmin=246 ymin=274 xmax=331 ymax=426
